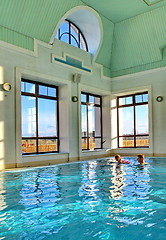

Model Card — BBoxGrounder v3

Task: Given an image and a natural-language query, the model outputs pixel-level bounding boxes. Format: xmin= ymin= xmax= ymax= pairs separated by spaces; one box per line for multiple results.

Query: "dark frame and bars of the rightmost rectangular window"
xmin=117 ymin=91 xmax=150 ymax=148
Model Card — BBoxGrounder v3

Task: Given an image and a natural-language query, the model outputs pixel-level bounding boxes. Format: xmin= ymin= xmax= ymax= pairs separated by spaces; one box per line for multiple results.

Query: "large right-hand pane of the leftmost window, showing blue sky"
xmin=38 ymin=98 xmax=57 ymax=137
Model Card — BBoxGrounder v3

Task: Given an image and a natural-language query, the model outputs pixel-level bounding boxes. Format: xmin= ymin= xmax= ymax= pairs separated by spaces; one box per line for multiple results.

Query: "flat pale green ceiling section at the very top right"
xmin=82 ymin=0 xmax=166 ymax=23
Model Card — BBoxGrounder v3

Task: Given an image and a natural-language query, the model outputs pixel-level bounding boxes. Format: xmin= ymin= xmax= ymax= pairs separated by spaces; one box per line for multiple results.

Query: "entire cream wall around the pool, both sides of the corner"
xmin=0 ymin=35 xmax=166 ymax=169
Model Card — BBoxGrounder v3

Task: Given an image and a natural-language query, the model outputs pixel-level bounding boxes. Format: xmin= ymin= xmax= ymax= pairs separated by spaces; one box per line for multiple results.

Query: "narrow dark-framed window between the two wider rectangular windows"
xmin=81 ymin=92 xmax=102 ymax=150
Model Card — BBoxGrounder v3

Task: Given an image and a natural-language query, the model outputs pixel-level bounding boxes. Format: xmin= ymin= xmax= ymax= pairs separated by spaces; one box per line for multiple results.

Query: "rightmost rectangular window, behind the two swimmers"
xmin=117 ymin=92 xmax=149 ymax=148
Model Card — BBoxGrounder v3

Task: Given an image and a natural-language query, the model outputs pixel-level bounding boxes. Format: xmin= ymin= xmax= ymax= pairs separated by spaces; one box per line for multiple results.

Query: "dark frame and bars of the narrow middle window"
xmin=81 ymin=91 xmax=103 ymax=151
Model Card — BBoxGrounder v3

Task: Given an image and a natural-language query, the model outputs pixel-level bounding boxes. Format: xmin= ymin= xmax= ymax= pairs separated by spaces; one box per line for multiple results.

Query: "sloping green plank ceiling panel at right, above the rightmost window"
xmin=111 ymin=6 xmax=166 ymax=77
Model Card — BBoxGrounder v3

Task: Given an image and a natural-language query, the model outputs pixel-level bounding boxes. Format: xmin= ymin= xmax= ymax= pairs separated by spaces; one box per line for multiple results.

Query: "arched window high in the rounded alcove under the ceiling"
xmin=56 ymin=19 xmax=88 ymax=52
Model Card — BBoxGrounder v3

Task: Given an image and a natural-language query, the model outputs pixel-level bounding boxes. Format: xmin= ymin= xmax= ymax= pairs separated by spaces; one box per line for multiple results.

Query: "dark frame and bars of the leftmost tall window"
xmin=21 ymin=78 xmax=60 ymax=155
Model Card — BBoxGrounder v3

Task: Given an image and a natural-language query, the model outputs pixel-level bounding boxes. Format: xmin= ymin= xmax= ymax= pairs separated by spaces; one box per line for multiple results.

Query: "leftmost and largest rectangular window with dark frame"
xmin=21 ymin=79 xmax=59 ymax=154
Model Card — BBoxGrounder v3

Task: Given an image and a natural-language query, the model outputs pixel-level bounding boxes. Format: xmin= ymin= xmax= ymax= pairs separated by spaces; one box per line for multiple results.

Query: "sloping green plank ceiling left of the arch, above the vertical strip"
xmin=0 ymin=0 xmax=84 ymax=42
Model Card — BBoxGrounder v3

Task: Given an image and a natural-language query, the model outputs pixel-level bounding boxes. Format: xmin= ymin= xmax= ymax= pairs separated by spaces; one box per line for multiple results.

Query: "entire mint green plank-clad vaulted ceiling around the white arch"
xmin=0 ymin=0 xmax=166 ymax=76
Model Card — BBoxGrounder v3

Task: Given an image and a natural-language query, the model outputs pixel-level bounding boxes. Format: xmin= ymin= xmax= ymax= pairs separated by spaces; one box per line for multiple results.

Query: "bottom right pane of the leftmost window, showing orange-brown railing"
xmin=38 ymin=139 xmax=58 ymax=152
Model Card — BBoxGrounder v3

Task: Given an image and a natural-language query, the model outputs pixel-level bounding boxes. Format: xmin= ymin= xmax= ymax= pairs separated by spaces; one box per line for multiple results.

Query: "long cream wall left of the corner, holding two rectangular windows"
xmin=0 ymin=40 xmax=111 ymax=169
